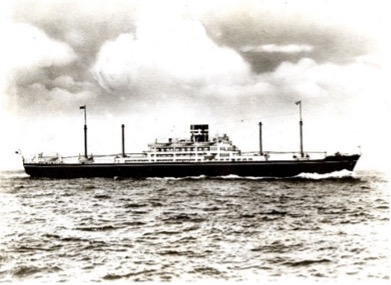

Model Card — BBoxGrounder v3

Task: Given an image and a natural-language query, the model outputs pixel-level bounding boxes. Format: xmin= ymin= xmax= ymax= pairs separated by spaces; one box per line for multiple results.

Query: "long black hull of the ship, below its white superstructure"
xmin=24 ymin=155 xmax=360 ymax=178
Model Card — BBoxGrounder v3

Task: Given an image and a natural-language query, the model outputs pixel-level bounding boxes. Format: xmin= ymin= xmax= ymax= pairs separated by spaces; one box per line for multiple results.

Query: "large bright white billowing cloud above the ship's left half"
xmin=92 ymin=4 xmax=250 ymax=96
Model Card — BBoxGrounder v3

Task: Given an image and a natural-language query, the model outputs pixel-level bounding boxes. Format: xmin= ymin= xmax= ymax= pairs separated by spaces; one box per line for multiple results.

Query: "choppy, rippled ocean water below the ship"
xmin=0 ymin=171 xmax=390 ymax=283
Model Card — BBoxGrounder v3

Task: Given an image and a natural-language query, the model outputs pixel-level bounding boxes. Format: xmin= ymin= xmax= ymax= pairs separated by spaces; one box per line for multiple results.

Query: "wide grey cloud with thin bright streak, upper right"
xmin=200 ymin=0 xmax=382 ymax=73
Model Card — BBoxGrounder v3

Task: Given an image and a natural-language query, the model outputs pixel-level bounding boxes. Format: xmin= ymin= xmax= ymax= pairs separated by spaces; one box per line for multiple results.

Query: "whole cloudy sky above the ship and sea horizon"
xmin=0 ymin=0 xmax=391 ymax=170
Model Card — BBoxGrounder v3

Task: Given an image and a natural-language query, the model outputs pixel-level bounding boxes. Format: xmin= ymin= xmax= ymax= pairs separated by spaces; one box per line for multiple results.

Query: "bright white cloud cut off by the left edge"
xmin=0 ymin=21 xmax=77 ymax=113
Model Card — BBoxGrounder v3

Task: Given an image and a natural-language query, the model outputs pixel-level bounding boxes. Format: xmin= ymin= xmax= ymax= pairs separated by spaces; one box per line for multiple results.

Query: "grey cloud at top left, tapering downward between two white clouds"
xmin=11 ymin=0 xmax=138 ymax=64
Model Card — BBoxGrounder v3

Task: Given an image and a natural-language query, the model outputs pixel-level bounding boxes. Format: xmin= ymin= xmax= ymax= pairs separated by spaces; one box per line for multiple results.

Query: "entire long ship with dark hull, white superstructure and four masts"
xmin=18 ymin=101 xmax=360 ymax=178
